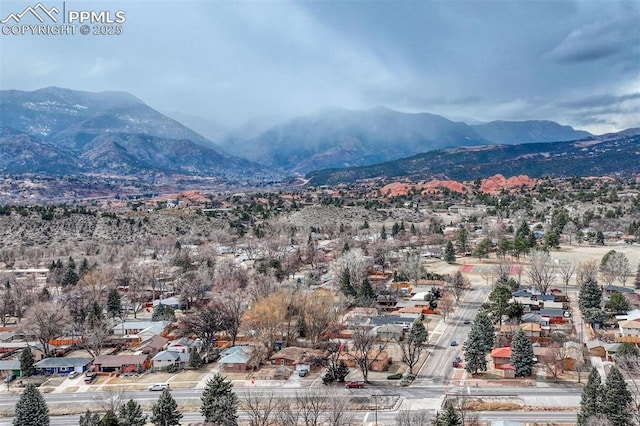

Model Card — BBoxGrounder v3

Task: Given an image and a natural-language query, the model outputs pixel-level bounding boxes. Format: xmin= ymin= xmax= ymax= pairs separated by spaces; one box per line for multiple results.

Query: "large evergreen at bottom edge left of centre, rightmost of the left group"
xmin=200 ymin=374 xmax=238 ymax=426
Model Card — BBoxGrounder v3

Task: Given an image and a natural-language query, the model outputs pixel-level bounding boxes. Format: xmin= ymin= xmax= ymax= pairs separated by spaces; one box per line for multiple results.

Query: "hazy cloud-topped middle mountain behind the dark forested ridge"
xmin=220 ymin=107 xmax=590 ymax=173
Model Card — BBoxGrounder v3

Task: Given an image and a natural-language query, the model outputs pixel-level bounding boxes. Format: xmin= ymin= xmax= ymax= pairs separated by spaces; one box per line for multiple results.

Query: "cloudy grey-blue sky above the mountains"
xmin=0 ymin=0 xmax=640 ymax=133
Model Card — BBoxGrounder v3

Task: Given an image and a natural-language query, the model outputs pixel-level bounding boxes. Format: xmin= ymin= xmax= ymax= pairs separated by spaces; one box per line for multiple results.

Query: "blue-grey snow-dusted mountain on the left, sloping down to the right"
xmin=0 ymin=87 xmax=274 ymax=178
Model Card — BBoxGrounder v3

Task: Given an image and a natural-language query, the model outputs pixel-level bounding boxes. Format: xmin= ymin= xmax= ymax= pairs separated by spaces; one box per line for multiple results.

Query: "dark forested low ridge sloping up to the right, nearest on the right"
xmin=306 ymin=128 xmax=640 ymax=185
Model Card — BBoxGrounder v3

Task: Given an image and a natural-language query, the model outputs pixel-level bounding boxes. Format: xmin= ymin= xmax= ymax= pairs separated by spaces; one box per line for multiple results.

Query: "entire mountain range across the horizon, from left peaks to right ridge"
xmin=0 ymin=87 xmax=640 ymax=184
